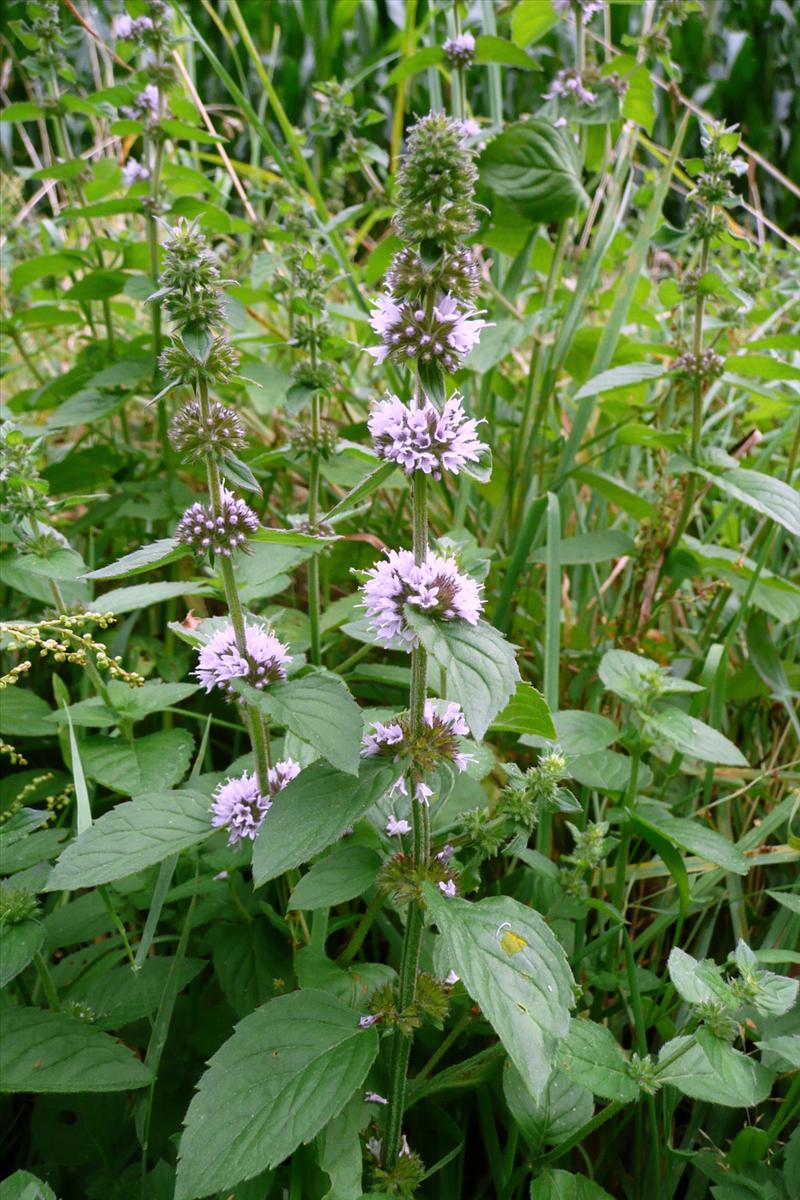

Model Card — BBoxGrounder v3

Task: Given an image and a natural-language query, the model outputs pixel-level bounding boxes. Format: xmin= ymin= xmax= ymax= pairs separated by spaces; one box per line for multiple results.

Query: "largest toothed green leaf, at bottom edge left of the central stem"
xmin=175 ymin=990 xmax=378 ymax=1200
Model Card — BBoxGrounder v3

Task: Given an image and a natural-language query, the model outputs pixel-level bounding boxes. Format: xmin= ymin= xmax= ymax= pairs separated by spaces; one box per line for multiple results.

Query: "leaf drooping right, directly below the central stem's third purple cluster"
xmin=405 ymin=605 xmax=519 ymax=740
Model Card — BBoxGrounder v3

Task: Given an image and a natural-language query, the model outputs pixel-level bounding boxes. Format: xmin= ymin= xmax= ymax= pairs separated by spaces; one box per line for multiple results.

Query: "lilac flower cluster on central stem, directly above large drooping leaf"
xmin=362 ymin=550 xmax=483 ymax=652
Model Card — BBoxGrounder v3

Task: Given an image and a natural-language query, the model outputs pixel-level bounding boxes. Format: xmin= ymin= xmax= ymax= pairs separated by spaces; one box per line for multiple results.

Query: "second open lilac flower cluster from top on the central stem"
xmin=368 ymin=392 xmax=488 ymax=479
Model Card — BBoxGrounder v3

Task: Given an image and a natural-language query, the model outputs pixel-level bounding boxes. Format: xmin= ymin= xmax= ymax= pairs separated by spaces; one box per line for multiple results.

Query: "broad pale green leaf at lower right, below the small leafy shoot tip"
xmin=658 ymin=1030 xmax=774 ymax=1109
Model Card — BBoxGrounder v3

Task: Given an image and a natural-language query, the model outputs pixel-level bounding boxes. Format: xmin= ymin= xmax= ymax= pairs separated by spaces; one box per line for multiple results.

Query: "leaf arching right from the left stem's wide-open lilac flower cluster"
xmin=235 ymin=671 xmax=363 ymax=775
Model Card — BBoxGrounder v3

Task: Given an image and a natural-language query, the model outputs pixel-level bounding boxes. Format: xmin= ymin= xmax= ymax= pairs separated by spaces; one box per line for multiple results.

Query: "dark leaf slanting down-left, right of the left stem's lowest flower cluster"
xmin=253 ymin=761 xmax=397 ymax=887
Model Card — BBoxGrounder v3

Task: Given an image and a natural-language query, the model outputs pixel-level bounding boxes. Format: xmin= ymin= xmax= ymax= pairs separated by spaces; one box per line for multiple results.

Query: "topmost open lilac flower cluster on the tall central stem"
xmin=367 ymin=292 xmax=487 ymax=372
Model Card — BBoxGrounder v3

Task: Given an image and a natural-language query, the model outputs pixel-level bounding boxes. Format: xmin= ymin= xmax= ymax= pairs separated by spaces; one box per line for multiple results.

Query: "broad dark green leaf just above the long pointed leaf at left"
xmin=82 ymin=730 xmax=194 ymax=796
